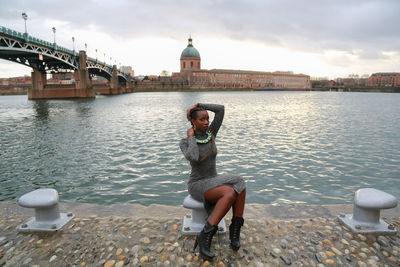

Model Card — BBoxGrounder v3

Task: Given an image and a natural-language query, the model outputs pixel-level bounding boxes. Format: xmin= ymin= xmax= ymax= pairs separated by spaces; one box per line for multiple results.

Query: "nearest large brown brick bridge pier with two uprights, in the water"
xmin=28 ymin=51 xmax=96 ymax=100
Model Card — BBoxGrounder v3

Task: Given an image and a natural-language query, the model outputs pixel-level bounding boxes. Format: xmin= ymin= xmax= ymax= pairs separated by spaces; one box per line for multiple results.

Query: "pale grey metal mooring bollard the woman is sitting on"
xmin=182 ymin=195 xmax=226 ymax=235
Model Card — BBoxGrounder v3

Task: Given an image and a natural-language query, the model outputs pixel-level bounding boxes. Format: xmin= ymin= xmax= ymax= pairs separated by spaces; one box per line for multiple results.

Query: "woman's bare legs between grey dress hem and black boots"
xmin=204 ymin=185 xmax=236 ymax=228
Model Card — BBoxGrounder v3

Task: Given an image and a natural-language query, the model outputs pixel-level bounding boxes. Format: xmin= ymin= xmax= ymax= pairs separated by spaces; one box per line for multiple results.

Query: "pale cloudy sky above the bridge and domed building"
xmin=0 ymin=0 xmax=400 ymax=78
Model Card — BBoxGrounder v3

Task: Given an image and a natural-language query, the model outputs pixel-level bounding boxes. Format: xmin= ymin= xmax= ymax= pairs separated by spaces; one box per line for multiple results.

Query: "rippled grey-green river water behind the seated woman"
xmin=0 ymin=92 xmax=400 ymax=205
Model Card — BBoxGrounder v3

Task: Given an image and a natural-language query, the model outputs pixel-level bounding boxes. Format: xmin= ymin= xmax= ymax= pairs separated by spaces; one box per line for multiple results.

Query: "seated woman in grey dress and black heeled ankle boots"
xmin=180 ymin=104 xmax=246 ymax=260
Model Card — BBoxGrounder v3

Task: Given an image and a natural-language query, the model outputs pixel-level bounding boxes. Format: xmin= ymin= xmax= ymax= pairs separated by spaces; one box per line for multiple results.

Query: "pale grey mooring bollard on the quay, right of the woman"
xmin=338 ymin=188 xmax=397 ymax=234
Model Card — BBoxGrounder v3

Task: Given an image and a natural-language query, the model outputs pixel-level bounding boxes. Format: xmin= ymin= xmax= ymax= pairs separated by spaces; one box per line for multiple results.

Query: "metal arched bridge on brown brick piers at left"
xmin=0 ymin=26 xmax=133 ymax=99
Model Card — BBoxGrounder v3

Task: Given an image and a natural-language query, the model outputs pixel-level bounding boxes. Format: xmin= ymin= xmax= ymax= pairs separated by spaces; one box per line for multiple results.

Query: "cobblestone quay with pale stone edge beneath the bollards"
xmin=0 ymin=202 xmax=400 ymax=267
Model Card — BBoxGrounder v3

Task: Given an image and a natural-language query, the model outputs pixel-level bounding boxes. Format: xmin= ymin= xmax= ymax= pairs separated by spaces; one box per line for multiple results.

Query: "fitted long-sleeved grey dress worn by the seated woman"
xmin=179 ymin=104 xmax=246 ymax=214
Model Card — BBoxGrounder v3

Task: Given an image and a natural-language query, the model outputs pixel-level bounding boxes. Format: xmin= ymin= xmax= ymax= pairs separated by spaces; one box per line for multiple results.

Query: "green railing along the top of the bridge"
xmin=0 ymin=25 xmax=127 ymax=78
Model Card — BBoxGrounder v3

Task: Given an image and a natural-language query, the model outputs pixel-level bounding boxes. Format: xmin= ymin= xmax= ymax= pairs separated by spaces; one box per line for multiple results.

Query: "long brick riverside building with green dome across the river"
xmin=172 ymin=38 xmax=311 ymax=89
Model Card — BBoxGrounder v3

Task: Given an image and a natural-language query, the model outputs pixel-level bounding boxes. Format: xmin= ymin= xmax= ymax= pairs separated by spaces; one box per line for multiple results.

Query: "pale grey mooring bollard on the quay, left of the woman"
xmin=18 ymin=188 xmax=74 ymax=232
